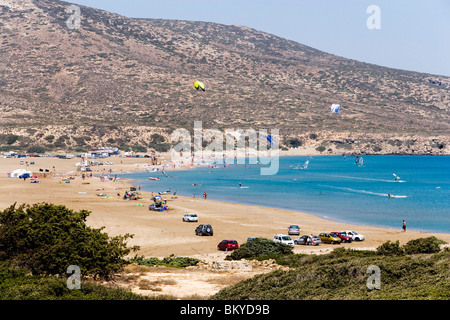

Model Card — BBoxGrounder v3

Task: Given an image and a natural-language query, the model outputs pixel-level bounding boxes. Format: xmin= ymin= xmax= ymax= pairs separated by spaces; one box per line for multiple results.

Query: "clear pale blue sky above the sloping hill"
xmin=66 ymin=0 xmax=450 ymax=76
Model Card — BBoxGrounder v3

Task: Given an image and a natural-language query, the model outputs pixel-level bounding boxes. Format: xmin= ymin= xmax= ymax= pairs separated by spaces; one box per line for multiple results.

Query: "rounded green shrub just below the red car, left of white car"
xmin=226 ymin=238 xmax=292 ymax=260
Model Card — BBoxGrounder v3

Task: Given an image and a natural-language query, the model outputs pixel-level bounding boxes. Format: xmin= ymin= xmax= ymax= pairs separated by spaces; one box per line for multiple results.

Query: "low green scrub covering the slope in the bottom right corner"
xmin=212 ymin=237 xmax=450 ymax=300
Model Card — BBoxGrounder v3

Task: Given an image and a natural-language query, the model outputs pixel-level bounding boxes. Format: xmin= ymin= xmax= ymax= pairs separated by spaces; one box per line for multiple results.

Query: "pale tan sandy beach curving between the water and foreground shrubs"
xmin=0 ymin=157 xmax=450 ymax=296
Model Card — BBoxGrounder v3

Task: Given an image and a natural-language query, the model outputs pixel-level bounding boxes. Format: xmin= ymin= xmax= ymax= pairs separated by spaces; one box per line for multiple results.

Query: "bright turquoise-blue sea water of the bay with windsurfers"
xmin=124 ymin=156 xmax=450 ymax=233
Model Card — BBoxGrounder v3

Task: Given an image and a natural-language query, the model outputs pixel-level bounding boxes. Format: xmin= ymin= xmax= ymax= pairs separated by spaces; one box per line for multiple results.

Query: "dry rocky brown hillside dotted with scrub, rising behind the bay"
xmin=0 ymin=0 xmax=450 ymax=154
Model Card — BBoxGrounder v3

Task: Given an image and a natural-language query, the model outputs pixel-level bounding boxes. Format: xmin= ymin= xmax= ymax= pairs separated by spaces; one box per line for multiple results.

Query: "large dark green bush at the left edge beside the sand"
xmin=0 ymin=203 xmax=138 ymax=277
